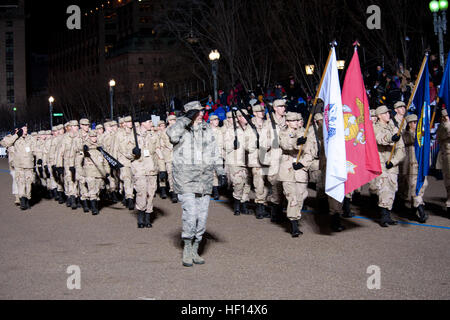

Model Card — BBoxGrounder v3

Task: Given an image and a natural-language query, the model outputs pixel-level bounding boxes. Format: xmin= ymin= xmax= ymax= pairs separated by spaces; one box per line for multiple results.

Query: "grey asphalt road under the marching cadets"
xmin=0 ymin=159 xmax=450 ymax=300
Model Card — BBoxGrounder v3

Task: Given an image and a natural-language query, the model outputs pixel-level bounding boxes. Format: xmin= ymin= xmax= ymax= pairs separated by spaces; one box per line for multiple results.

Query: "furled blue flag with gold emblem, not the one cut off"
xmin=413 ymin=58 xmax=431 ymax=195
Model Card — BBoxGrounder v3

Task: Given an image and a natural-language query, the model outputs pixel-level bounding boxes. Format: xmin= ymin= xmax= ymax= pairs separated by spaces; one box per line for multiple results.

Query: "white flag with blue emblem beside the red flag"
xmin=319 ymin=48 xmax=347 ymax=202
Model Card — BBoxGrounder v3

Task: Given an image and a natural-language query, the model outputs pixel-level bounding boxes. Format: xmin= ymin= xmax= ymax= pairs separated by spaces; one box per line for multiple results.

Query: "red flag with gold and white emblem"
xmin=342 ymin=48 xmax=381 ymax=194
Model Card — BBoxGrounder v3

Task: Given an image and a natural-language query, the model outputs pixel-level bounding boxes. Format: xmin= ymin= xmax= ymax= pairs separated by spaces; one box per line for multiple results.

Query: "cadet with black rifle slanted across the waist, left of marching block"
xmin=77 ymin=130 xmax=109 ymax=216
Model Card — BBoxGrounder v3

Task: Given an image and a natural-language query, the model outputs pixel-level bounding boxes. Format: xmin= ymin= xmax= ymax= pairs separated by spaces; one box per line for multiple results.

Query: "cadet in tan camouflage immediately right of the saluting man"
xmin=224 ymin=110 xmax=252 ymax=216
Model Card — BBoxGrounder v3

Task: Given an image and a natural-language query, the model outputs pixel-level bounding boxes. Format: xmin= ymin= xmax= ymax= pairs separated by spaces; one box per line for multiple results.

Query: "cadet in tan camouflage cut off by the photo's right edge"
xmin=436 ymin=110 xmax=450 ymax=217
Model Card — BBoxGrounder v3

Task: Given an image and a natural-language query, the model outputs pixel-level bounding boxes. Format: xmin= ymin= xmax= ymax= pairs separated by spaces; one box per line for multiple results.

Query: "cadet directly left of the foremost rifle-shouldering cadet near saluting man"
xmin=113 ymin=116 xmax=136 ymax=210
